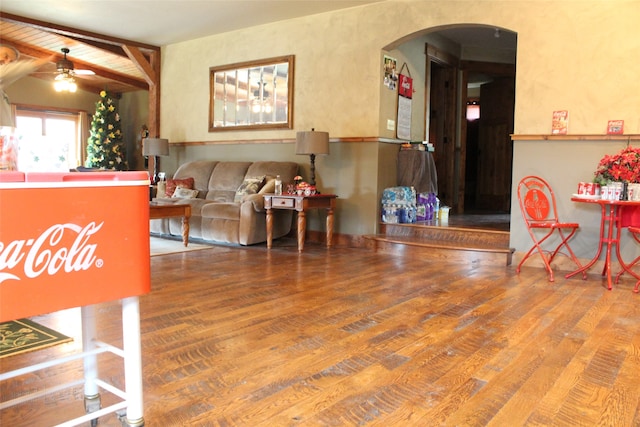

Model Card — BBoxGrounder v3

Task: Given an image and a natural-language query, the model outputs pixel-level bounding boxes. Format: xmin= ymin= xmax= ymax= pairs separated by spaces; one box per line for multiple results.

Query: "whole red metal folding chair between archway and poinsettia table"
xmin=516 ymin=175 xmax=586 ymax=282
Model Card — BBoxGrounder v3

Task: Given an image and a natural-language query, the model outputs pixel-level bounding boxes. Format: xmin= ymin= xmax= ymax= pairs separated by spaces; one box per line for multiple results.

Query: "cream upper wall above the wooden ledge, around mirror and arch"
xmin=162 ymin=1 xmax=640 ymax=141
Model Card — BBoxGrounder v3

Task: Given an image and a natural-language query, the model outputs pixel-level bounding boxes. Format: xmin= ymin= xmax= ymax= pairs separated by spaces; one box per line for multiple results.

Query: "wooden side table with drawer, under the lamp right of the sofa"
xmin=264 ymin=194 xmax=338 ymax=252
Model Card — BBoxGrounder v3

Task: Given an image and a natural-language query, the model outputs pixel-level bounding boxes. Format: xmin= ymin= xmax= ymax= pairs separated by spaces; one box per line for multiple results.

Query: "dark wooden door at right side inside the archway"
xmin=476 ymin=77 xmax=515 ymax=212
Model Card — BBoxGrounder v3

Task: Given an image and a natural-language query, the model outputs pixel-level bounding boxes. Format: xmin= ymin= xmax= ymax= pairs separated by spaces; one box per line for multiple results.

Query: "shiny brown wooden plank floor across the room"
xmin=0 ymin=237 xmax=640 ymax=427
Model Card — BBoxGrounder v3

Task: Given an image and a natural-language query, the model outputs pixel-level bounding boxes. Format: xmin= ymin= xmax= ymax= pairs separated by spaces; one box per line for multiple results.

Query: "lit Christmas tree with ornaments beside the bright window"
xmin=85 ymin=90 xmax=128 ymax=170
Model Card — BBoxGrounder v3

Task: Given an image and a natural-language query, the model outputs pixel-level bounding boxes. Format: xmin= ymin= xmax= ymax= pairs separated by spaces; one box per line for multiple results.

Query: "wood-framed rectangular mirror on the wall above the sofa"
xmin=209 ymin=55 xmax=294 ymax=132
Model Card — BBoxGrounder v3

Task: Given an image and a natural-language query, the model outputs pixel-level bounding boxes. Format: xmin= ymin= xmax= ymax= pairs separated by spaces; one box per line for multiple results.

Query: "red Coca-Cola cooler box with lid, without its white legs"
xmin=0 ymin=172 xmax=150 ymax=321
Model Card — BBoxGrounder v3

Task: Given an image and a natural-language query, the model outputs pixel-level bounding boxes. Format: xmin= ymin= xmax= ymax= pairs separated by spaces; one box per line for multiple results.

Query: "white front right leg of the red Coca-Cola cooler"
xmin=121 ymin=297 xmax=144 ymax=427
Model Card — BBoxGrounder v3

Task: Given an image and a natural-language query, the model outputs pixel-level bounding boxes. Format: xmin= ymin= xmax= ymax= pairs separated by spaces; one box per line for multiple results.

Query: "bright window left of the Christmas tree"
xmin=16 ymin=107 xmax=83 ymax=172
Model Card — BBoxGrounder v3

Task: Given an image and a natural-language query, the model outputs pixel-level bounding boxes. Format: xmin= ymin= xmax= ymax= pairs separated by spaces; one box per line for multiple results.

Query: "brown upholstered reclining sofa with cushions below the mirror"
xmin=150 ymin=160 xmax=298 ymax=245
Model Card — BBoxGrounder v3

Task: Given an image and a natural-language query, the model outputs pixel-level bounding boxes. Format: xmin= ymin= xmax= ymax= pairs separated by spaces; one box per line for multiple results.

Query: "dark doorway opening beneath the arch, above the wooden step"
xmin=384 ymin=24 xmax=517 ymax=224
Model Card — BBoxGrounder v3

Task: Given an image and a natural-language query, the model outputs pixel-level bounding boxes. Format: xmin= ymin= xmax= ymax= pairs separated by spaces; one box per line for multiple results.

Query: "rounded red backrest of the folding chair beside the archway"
xmin=518 ymin=175 xmax=558 ymax=225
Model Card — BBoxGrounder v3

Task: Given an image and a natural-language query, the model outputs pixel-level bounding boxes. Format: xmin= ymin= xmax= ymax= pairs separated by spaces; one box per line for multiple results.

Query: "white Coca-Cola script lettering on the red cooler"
xmin=0 ymin=222 xmax=104 ymax=283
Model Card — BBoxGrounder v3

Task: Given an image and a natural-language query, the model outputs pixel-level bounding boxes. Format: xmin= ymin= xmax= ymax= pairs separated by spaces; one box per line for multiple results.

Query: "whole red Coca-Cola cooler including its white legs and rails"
xmin=0 ymin=171 xmax=151 ymax=426
